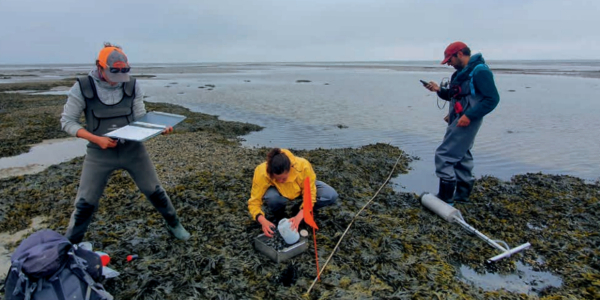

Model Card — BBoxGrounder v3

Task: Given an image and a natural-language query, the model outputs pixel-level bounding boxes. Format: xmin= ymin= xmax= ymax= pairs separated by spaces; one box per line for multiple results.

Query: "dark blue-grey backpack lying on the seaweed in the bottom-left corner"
xmin=4 ymin=229 xmax=113 ymax=300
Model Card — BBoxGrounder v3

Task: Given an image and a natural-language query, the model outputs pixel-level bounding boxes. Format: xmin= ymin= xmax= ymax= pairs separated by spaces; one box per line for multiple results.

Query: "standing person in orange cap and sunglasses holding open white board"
xmin=60 ymin=43 xmax=190 ymax=244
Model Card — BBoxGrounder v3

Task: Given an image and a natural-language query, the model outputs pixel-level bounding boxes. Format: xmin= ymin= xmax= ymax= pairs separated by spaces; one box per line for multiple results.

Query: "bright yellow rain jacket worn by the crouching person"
xmin=248 ymin=149 xmax=317 ymax=220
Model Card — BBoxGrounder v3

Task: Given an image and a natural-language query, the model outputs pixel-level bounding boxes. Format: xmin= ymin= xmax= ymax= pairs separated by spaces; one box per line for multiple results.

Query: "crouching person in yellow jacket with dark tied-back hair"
xmin=248 ymin=148 xmax=338 ymax=237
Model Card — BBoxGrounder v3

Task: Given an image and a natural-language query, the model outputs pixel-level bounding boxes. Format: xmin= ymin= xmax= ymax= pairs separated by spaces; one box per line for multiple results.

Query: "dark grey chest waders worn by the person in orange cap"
xmin=66 ymin=77 xmax=189 ymax=243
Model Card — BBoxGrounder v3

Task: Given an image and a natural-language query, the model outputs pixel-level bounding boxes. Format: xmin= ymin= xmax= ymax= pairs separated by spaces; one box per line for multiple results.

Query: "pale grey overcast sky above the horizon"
xmin=0 ymin=0 xmax=600 ymax=64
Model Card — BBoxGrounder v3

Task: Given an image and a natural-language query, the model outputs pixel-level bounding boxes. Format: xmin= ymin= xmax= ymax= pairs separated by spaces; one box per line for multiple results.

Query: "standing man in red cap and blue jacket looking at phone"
xmin=425 ymin=42 xmax=500 ymax=204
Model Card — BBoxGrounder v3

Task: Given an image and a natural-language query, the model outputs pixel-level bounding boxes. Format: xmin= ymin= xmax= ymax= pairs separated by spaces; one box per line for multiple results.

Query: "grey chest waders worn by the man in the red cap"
xmin=435 ymin=64 xmax=489 ymax=203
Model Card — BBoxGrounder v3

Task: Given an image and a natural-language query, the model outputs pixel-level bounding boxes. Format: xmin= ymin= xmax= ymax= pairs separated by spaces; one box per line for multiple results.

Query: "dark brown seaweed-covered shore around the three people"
xmin=0 ymin=79 xmax=600 ymax=299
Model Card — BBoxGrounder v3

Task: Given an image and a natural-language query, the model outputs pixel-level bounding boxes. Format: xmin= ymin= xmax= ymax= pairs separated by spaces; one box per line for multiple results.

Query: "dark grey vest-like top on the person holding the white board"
xmin=77 ymin=76 xmax=135 ymax=136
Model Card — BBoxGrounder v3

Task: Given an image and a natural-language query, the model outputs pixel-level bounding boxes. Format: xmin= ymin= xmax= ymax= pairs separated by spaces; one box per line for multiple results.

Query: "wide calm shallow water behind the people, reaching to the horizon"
xmin=0 ymin=61 xmax=600 ymax=193
